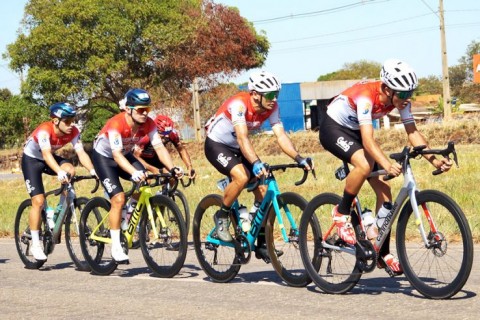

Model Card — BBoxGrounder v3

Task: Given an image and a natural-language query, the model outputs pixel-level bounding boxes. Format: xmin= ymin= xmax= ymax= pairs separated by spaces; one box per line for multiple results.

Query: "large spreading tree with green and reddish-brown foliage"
xmin=5 ymin=0 xmax=269 ymax=113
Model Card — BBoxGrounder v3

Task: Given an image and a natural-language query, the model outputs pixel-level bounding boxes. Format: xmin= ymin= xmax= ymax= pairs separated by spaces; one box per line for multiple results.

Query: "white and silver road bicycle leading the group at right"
xmin=300 ymin=142 xmax=473 ymax=299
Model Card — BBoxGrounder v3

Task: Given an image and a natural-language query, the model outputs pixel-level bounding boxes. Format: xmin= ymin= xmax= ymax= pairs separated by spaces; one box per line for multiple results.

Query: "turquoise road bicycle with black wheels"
xmin=193 ymin=163 xmax=314 ymax=287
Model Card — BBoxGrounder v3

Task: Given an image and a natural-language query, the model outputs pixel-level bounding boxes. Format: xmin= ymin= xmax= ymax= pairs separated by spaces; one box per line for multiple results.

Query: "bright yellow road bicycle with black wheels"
xmin=80 ymin=172 xmax=187 ymax=278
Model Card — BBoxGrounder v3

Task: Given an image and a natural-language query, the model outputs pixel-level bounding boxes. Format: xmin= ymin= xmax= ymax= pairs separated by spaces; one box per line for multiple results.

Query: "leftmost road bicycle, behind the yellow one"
xmin=14 ymin=175 xmax=99 ymax=271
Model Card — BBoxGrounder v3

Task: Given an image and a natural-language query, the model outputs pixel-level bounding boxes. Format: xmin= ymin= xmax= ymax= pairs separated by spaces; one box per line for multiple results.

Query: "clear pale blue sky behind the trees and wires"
xmin=0 ymin=0 xmax=480 ymax=93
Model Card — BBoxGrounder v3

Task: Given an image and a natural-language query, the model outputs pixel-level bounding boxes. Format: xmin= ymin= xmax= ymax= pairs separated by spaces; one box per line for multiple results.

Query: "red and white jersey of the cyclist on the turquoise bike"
xmin=207 ymin=92 xmax=282 ymax=148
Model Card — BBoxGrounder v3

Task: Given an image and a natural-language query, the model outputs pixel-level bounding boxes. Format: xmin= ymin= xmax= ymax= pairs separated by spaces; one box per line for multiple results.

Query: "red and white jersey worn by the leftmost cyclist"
xmin=23 ymin=121 xmax=83 ymax=160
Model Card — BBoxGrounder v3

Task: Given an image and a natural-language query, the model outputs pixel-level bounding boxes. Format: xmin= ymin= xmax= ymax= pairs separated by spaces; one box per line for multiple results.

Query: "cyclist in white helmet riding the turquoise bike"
xmin=205 ymin=71 xmax=313 ymax=259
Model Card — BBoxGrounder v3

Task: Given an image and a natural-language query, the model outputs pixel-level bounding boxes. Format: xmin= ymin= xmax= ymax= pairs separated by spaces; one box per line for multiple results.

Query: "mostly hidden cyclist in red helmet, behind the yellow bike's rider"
xmin=134 ymin=115 xmax=195 ymax=179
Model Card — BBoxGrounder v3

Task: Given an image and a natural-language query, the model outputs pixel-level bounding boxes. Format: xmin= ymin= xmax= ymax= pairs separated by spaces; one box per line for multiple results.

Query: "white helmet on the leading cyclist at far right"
xmin=380 ymin=59 xmax=418 ymax=91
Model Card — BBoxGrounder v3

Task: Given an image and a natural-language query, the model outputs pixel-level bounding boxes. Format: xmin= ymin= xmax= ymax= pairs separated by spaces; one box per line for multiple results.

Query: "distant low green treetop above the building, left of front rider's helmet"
xmin=317 ymin=60 xmax=382 ymax=81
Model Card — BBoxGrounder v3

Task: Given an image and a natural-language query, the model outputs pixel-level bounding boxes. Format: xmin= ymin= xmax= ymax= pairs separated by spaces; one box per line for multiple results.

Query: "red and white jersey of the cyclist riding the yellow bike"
xmin=93 ymin=112 xmax=162 ymax=158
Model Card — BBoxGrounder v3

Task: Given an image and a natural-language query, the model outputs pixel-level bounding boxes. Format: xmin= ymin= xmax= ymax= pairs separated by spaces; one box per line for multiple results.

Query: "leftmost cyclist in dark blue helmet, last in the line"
xmin=22 ymin=102 xmax=95 ymax=261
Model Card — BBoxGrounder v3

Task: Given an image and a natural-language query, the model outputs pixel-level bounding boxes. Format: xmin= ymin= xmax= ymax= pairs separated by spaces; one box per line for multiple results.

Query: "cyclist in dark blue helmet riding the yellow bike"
xmin=92 ymin=88 xmax=182 ymax=263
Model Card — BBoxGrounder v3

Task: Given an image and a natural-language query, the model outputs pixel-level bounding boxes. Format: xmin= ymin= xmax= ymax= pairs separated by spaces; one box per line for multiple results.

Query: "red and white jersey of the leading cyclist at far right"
xmin=327 ymin=81 xmax=414 ymax=130
